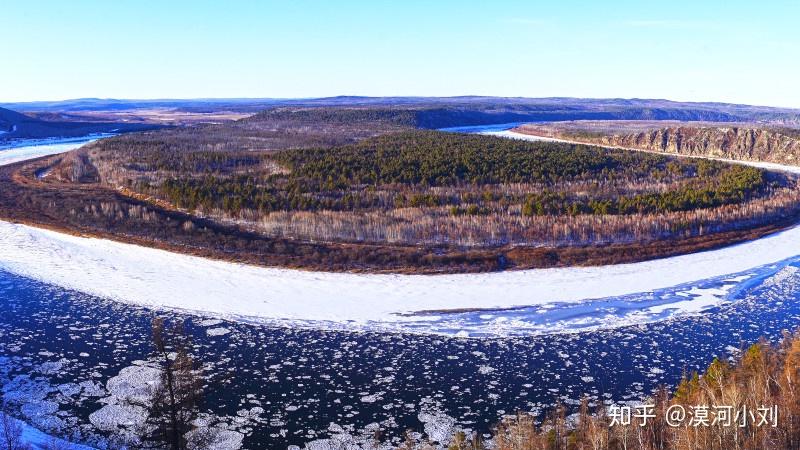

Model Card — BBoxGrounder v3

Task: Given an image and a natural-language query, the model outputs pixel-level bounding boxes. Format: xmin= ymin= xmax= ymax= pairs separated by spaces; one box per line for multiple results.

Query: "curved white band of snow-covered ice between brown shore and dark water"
xmin=0 ymin=134 xmax=800 ymax=336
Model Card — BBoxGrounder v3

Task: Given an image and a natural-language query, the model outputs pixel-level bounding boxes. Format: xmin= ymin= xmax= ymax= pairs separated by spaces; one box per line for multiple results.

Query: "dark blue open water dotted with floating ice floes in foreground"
xmin=0 ymin=260 xmax=800 ymax=448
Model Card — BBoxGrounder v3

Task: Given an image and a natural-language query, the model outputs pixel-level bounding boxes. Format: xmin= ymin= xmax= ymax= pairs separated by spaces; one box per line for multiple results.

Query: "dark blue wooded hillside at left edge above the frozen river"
xmin=0 ymin=108 xmax=158 ymax=140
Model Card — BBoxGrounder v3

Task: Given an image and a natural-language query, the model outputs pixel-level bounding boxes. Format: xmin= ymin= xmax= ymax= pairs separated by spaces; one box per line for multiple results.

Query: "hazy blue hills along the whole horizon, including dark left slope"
xmin=6 ymin=96 xmax=800 ymax=139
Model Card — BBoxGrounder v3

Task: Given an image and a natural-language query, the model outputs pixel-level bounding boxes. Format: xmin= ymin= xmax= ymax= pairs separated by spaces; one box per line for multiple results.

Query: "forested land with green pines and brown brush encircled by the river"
xmin=0 ymin=106 xmax=800 ymax=273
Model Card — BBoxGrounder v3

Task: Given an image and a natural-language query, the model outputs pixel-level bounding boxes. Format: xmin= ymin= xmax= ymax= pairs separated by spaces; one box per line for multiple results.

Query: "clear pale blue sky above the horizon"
xmin=0 ymin=0 xmax=800 ymax=107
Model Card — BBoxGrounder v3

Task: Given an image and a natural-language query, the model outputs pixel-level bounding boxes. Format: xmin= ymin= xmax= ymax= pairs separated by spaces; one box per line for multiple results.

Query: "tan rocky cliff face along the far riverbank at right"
xmin=519 ymin=126 xmax=800 ymax=165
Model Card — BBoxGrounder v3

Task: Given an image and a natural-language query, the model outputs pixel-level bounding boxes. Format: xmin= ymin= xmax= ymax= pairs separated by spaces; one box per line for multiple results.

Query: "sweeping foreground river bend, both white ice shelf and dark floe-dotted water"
xmin=0 ymin=132 xmax=800 ymax=448
